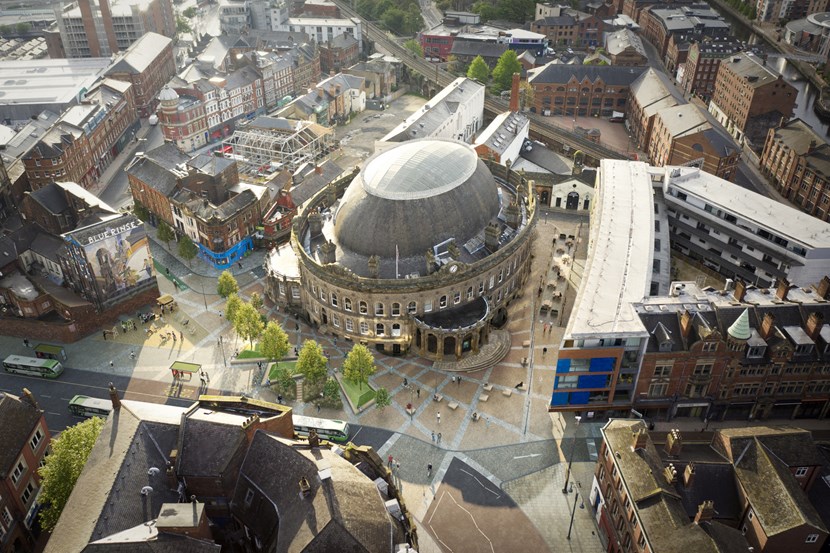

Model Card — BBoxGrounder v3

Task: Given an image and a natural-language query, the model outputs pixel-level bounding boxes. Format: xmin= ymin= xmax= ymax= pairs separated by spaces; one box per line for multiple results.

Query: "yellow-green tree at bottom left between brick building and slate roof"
xmin=39 ymin=417 xmax=104 ymax=532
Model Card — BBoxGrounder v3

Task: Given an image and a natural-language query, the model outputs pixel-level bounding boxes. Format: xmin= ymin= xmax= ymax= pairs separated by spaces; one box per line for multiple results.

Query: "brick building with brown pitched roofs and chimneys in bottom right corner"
xmin=600 ymin=419 xmax=827 ymax=553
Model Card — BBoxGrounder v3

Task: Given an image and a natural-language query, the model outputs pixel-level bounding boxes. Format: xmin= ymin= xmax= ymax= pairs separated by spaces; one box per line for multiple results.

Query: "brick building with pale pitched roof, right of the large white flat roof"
xmin=107 ymin=33 xmax=176 ymax=117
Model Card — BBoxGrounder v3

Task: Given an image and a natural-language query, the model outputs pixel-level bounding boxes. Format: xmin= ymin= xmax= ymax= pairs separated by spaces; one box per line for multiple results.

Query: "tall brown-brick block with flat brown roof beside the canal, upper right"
xmin=709 ymin=53 xmax=797 ymax=146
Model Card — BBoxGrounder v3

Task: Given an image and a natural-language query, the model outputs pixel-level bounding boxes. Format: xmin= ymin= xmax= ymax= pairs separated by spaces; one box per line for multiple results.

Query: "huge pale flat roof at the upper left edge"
xmin=0 ymin=58 xmax=111 ymax=105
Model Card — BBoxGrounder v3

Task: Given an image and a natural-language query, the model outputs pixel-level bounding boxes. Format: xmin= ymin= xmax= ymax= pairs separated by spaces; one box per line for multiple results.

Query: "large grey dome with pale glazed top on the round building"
xmin=334 ymin=138 xmax=499 ymax=258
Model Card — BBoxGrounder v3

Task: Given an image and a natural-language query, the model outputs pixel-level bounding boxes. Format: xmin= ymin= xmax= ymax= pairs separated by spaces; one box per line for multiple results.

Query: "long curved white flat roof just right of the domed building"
xmin=565 ymin=159 xmax=654 ymax=339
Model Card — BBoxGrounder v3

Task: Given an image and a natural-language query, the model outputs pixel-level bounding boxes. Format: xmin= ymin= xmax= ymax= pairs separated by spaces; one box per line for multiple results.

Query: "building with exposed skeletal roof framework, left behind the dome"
xmin=221 ymin=116 xmax=336 ymax=175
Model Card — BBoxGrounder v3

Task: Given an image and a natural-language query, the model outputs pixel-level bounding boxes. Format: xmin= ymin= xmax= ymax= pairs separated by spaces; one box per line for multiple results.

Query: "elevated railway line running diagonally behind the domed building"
xmin=335 ymin=0 xmax=626 ymax=165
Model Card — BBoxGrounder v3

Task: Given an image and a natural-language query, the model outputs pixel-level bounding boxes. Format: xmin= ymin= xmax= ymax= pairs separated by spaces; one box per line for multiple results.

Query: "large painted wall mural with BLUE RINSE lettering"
xmin=80 ymin=216 xmax=154 ymax=301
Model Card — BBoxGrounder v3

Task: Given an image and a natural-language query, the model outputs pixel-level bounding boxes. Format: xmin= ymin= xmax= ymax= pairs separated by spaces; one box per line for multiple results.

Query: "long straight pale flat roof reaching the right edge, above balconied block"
xmin=664 ymin=167 xmax=830 ymax=249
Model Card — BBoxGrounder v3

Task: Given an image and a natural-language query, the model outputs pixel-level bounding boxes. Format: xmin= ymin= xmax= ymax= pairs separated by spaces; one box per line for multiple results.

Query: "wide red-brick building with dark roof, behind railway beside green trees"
xmin=527 ymin=63 xmax=645 ymax=117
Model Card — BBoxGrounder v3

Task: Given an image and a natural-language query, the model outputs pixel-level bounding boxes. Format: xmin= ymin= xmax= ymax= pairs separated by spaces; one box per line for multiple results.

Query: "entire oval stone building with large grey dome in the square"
xmin=266 ymin=139 xmax=536 ymax=360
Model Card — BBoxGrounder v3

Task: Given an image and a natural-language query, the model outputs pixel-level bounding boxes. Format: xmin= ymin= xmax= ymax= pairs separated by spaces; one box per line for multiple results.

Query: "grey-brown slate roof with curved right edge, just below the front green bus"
xmin=231 ymin=431 xmax=401 ymax=553
